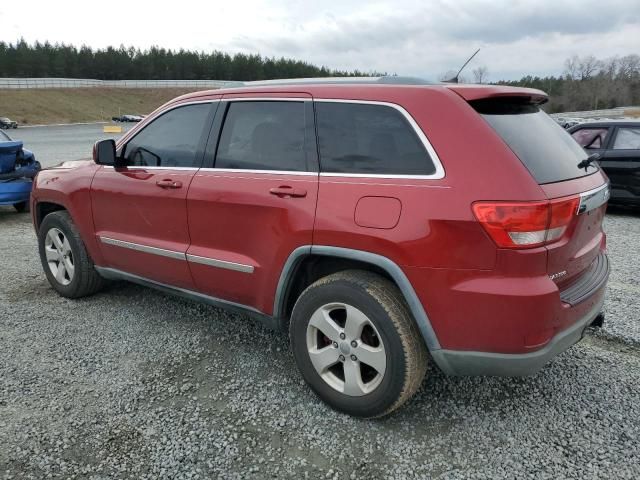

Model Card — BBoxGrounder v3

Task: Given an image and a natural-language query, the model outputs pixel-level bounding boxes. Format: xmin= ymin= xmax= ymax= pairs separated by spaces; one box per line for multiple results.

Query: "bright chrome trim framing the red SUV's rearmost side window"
xmin=313 ymin=98 xmax=445 ymax=180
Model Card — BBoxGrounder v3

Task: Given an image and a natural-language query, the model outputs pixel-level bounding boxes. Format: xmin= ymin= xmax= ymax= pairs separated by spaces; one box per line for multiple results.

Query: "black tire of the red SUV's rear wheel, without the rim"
xmin=289 ymin=270 xmax=427 ymax=418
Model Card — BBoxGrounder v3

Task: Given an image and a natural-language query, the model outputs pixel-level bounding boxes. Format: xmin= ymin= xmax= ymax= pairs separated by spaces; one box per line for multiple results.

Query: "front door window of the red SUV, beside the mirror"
xmin=123 ymin=103 xmax=211 ymax=167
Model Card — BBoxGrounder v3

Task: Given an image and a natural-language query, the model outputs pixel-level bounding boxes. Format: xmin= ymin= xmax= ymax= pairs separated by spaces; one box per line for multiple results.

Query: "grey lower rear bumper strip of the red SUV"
xmin=431 ymin=293 xmax=604 ymax=377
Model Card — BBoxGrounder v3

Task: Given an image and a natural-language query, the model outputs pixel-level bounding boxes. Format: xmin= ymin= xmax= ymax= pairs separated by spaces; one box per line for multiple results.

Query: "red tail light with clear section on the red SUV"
xmin=473 ymin=197 xmax=580 ymax=248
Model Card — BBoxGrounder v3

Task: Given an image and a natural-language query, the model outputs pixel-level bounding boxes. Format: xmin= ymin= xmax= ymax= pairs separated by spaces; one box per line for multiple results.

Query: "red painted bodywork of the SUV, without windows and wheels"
xmin=32 ymin=85 xmax=606 ymax=360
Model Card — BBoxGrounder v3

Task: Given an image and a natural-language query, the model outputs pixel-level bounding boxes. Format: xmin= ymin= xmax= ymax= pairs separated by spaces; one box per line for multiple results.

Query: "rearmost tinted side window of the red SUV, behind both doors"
xmin=315 ymin=102 xmax=436 ymax=175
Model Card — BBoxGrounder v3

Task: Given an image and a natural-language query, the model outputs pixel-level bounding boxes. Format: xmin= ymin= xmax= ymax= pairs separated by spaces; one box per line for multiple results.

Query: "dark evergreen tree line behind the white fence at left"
xmin=0 ymin=40 xmax=374 ymax=81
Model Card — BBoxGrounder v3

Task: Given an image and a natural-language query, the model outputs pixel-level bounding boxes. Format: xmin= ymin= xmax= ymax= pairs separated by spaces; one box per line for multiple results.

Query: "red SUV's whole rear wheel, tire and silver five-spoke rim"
xmin=290 ymin=270 xmax=427 ymax=417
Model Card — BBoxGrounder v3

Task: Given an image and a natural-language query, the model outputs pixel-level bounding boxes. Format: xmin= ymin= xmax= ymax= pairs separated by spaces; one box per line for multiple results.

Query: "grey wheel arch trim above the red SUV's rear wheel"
xmin=273 ymin=245 xmax=440 ymax=351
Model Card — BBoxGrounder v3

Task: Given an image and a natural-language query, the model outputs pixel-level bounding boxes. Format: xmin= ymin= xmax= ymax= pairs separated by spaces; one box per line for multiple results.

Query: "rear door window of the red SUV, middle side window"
xmin=215 ymin=101 xmax=308 ymax=172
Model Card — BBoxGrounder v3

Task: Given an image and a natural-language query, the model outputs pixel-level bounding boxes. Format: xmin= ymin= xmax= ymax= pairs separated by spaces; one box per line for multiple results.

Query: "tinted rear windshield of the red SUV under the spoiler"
xmin=471 ymin=99 xmax=598 ymax=184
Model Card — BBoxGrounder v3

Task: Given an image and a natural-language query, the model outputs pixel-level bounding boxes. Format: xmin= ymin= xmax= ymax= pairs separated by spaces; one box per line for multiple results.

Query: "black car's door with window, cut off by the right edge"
xmin=600 ymin=126 xmax=640 ymax=202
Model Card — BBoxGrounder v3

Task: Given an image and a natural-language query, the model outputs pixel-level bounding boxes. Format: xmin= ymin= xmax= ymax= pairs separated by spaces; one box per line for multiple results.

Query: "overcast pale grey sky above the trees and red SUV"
xmin=0 ymin=0 xmax=640 ymax=81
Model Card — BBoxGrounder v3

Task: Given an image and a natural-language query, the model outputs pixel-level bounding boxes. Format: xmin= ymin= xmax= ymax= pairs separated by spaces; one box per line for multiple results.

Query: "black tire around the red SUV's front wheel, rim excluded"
xmin=38 ymin=210 xmax=105 ymax=298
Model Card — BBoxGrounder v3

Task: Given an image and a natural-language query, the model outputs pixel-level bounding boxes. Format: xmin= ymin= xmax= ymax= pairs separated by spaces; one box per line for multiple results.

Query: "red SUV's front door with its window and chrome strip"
xmin=91 ymin=101 xmax=218 ymax=288
